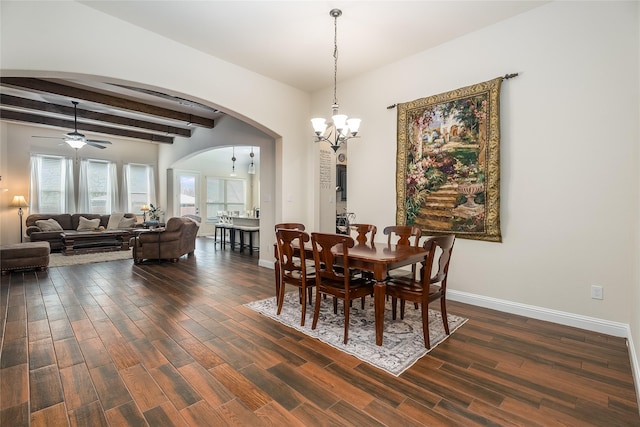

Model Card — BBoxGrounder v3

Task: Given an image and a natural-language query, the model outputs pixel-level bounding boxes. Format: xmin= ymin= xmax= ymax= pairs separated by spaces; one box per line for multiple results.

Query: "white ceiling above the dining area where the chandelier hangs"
xmin=81 ymin=0 xmax=547 ymax=92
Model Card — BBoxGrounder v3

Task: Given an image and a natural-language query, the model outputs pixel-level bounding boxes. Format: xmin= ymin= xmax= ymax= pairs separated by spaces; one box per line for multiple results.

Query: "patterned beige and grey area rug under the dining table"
xmin=245 ymin=292 xmax=467 ymax=376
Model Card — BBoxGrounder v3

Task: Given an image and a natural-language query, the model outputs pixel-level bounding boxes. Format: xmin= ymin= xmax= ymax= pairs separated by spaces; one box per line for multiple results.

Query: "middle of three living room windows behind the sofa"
xmin=78 ymin=159 xmax=119 ymax=215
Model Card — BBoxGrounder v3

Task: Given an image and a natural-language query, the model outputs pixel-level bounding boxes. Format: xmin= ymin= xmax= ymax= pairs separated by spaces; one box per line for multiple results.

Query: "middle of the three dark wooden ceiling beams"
xmin=0 ymin=94 xmax=191 ymax=138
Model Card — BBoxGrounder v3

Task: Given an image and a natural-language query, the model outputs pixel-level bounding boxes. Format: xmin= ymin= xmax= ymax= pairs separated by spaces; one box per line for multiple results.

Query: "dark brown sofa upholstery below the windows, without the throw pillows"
xmin=25 ymin=213 xmax=137 ymax=252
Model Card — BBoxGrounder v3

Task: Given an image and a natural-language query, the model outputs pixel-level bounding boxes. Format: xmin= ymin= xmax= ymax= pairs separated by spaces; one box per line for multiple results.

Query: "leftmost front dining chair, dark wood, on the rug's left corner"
xmin=276 ymin=228 xmax=316 ymax=326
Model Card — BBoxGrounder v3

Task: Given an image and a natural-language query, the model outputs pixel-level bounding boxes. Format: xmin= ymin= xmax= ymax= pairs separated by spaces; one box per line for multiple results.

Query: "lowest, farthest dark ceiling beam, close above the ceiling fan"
xmin=0 ymin=108 xmax=173 ymax=144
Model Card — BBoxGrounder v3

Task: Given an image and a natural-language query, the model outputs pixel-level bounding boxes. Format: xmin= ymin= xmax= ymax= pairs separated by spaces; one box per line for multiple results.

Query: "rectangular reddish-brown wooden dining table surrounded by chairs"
xmin=274 ymin=242 xmax=428 ymax=345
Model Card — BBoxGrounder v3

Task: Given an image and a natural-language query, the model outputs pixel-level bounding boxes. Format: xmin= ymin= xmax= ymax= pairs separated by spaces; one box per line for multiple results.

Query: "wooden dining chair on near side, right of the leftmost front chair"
xmin=311 ymin=233 xmax=373 ymax=344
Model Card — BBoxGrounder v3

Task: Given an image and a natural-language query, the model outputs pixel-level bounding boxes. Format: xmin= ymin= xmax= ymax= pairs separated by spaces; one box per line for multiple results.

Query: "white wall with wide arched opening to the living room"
xmin=0 ymin=1 xmax=316 ymax=264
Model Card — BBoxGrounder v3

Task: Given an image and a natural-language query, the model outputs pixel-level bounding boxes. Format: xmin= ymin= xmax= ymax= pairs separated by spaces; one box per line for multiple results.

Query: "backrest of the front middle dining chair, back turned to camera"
xmin=311 ymin=233 xmax=355 ymax=290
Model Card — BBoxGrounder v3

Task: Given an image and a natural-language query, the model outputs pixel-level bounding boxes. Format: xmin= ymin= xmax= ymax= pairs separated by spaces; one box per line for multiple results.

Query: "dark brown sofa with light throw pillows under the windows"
xmin=25 ymin=213 xmax=138 ymax=252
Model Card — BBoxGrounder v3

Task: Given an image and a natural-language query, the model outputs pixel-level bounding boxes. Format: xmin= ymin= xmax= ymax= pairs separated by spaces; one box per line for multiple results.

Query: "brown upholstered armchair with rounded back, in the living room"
xmin=131 ymin=217 xmax=200 ymax=264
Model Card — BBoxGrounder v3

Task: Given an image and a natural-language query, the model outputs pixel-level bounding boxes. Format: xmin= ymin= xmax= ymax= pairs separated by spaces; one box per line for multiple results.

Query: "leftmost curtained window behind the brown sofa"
xmin=29 ymin=154 xmax=76 ymax=214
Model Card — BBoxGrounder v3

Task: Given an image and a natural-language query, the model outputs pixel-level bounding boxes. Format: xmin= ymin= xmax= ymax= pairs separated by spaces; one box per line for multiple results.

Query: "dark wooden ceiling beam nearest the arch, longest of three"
xmin=0 ymin=77 xmax=214 ymax=129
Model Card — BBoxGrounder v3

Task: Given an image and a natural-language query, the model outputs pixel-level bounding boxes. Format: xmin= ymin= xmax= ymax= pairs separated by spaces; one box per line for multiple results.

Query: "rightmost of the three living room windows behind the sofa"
xmin=122 ymin=163 xmax=156 ymax=213
